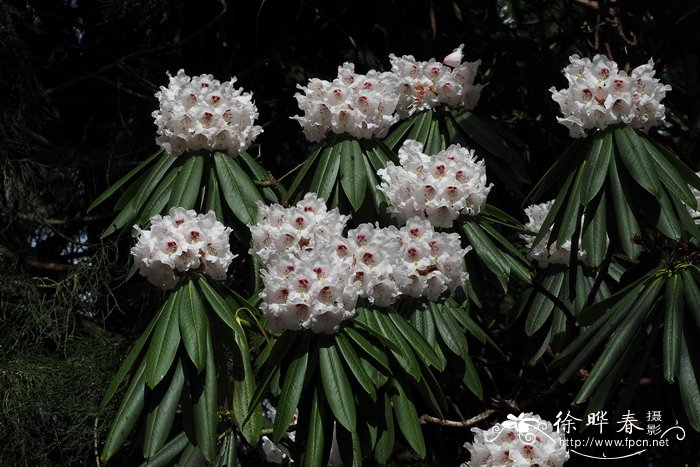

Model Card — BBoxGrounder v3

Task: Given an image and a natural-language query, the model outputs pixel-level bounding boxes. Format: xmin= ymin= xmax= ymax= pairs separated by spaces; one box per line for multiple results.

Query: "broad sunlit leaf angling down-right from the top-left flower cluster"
xmin=214 ymin=152 xmax=262 ymax=225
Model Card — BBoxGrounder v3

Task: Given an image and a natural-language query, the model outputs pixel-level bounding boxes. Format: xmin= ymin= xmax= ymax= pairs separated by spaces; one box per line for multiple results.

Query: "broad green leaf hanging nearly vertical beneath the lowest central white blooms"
xmin=318 ymin=345 xmax=357 ymax=431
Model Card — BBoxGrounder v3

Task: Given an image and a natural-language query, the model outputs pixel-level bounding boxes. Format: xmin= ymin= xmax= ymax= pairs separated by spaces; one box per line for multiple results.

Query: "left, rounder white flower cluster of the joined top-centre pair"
xmin=292 ymin=63 xmax=398 ymax=141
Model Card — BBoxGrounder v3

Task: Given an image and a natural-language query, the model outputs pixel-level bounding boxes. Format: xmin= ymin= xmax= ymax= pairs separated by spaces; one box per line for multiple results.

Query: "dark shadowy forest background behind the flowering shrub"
xmin=0 ymin=0 xmax=700 ymax=465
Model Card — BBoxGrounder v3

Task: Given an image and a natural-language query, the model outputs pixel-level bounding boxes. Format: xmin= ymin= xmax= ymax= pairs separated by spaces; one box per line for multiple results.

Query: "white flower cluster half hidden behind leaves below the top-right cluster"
xmin=520 ymin=200 xmax=586 ymax=268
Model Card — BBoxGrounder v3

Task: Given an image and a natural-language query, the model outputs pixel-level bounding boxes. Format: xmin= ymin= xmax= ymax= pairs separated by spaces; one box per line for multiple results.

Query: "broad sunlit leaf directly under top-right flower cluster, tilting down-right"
xmin=613 ymin=126 xmax=661 ymax=198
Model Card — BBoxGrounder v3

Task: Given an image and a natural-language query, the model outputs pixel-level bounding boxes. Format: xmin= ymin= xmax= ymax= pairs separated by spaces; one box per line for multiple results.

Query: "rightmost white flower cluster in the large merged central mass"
xmin=399 ymin=217 xmax=471 ymax=301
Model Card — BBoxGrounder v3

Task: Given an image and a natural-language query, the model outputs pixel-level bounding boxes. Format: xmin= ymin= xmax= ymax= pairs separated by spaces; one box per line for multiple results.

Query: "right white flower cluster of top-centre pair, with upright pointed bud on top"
xmin=389 ymin=44 xmax=484 ymax=119
